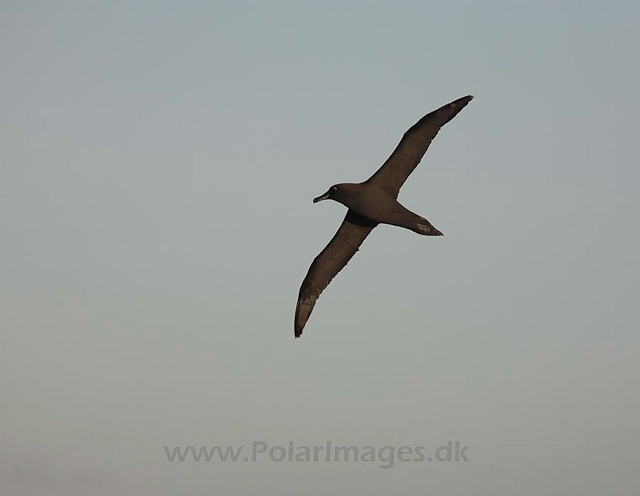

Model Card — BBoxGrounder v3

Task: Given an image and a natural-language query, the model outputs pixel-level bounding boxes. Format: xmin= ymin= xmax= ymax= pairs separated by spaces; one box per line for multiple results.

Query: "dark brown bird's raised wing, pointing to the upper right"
xmin=367 ymin=95 xmax=473 ymax=198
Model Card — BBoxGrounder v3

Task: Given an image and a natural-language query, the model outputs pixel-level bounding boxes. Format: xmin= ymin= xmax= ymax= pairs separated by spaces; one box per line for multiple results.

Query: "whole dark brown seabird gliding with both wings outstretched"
xmin=294 ymin=95 xmax=473 ymax=338
